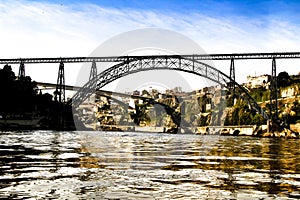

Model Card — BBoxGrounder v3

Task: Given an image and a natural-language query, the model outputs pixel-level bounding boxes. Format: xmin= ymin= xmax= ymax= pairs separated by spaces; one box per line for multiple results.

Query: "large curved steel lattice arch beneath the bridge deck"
xmin=68 ymin=55 xmax=269 ymax=119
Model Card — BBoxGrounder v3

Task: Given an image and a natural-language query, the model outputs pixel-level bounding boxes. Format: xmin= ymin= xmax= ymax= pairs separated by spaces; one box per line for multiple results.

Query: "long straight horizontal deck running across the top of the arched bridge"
xmin=0 ymin=52 xmax=300 ymax=64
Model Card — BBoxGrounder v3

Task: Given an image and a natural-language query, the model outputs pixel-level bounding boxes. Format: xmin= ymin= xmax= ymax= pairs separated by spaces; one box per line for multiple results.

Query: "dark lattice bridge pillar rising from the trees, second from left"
xmin=54 ymin=61 xmax=66 ymax=102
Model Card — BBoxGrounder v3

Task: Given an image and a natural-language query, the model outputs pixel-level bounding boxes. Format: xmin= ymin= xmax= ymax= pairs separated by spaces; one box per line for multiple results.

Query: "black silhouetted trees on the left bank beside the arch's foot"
xmin=0 ymin=65 xmax=72 ymax=129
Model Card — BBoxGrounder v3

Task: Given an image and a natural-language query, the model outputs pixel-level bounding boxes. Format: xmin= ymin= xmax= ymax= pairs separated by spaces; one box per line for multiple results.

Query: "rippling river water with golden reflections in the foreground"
xmin=0 ymin=131 xmax=300 ymax=199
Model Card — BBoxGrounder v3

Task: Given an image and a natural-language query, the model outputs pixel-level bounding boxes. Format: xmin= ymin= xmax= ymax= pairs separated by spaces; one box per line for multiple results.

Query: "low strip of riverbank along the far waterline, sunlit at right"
xmin=0 ymin=117 xmax=300 ymax=139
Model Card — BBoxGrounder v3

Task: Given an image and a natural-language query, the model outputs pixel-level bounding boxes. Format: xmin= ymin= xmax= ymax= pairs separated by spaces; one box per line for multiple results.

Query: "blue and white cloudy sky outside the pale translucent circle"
xmin=0 ymin=0 xmax=300 ymax=91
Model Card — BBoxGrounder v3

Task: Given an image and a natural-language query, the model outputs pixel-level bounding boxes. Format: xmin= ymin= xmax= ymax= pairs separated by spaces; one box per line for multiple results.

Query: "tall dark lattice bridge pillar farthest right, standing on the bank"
xmin=270 ymin=57 xmax=278 ymax=121
